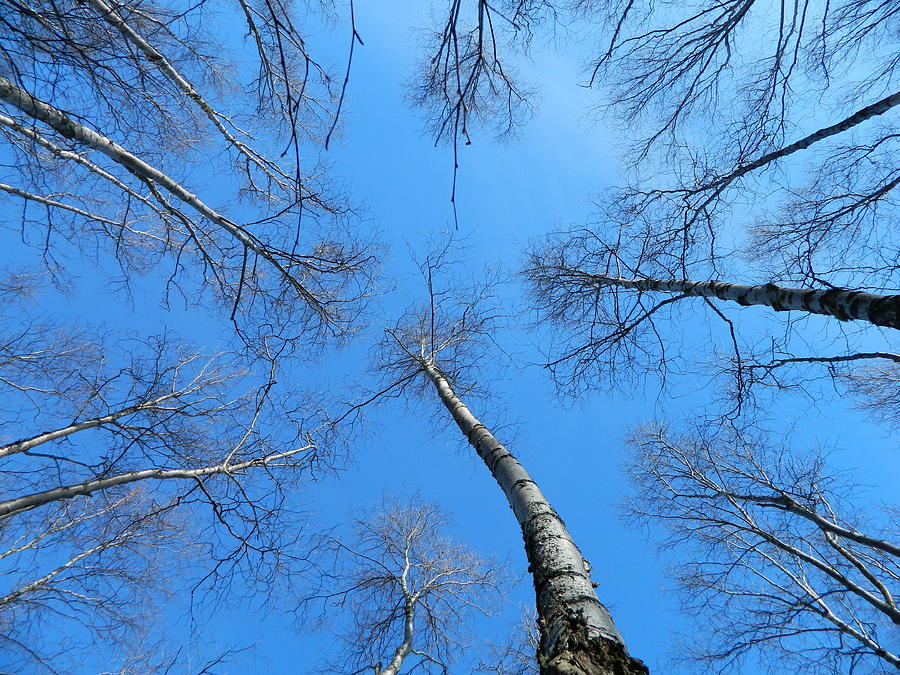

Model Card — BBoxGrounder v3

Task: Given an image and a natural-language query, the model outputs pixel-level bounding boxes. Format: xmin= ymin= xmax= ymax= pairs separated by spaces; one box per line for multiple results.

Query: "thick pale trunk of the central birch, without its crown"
xmin=424 ymin=363 xmax=648 ymax=675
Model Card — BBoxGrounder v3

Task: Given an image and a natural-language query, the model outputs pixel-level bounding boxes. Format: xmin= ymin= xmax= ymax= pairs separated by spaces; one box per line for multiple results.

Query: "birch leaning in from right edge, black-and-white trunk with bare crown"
xmin=523 ymin=230 xmax=900 ymax=407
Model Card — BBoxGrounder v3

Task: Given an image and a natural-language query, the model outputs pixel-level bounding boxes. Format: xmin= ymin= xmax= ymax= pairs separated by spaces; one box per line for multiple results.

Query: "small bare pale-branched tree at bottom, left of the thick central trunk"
xmin=304 ymin=500 xmax=502 ymax=675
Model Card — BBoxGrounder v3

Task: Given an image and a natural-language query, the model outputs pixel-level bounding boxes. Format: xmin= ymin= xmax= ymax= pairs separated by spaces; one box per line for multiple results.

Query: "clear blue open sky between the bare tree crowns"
xmin=5 ymin=0 xmax=900 ymax=673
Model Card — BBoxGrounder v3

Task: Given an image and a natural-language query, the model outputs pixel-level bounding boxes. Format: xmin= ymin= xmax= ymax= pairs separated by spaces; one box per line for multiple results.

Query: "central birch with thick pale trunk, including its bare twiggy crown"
xmin=381 ymin=255 xmax=647 ymax=674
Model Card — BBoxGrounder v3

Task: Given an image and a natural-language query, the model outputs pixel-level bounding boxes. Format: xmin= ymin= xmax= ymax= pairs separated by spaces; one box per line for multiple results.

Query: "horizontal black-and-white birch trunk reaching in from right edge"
xmin=586 ymin=274 xmax=900 ymax=329
